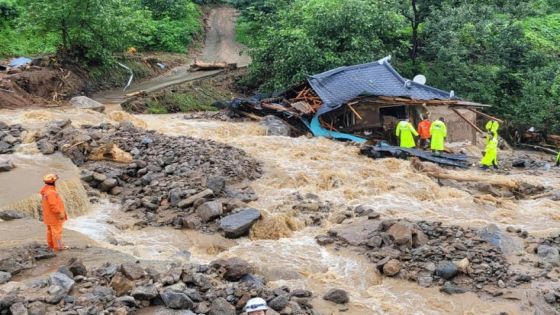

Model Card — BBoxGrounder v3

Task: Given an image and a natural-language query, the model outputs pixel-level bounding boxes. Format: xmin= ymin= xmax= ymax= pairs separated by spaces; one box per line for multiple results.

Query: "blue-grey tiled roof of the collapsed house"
xmin=308 ymin=57 xmax=456 ymax=114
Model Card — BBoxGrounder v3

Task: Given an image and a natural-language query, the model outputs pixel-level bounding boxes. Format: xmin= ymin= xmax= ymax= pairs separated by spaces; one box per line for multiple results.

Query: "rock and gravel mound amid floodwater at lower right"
xmin=317 ymin=218 xmax=520 ymax=293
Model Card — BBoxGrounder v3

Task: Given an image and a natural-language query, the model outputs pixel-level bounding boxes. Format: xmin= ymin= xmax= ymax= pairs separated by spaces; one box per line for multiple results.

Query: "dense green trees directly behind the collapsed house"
xmin=230 ymin=0 xmax=560 ymax=133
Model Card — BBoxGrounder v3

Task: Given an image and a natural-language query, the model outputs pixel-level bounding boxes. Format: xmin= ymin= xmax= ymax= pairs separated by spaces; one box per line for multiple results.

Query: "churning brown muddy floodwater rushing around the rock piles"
xmin=0 ymin=110 xmax=560 ymax=315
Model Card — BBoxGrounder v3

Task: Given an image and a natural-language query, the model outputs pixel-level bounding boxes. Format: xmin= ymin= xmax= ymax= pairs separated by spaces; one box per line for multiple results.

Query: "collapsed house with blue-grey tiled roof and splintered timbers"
xmin=230 ymin=57 xmax=488 ymax=143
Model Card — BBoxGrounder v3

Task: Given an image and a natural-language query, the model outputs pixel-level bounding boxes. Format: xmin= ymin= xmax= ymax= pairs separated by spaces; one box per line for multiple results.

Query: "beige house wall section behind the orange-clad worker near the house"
xmin=428 ymin=106 xmax=476 ymax=143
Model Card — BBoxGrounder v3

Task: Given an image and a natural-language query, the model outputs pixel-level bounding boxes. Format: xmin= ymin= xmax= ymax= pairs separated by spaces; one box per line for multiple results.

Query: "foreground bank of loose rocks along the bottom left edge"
xmin=0 ymin=258 xmax=316 ymax=315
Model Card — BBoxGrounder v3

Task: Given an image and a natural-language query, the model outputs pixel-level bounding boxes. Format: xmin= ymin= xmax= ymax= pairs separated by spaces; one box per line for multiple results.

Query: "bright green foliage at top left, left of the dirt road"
xmin=0 ymin=0 xmax=202 ymax=64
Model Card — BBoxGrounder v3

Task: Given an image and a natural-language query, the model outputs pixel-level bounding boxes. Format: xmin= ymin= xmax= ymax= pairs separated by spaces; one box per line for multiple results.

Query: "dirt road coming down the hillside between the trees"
xmin=92 ymin=7 xmax=251 ymax=104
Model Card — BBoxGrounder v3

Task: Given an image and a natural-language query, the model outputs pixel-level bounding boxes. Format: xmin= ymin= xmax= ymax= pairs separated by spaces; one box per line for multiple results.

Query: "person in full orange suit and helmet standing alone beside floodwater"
xmin=41 ymin=174 xmax=68 ymax=252
